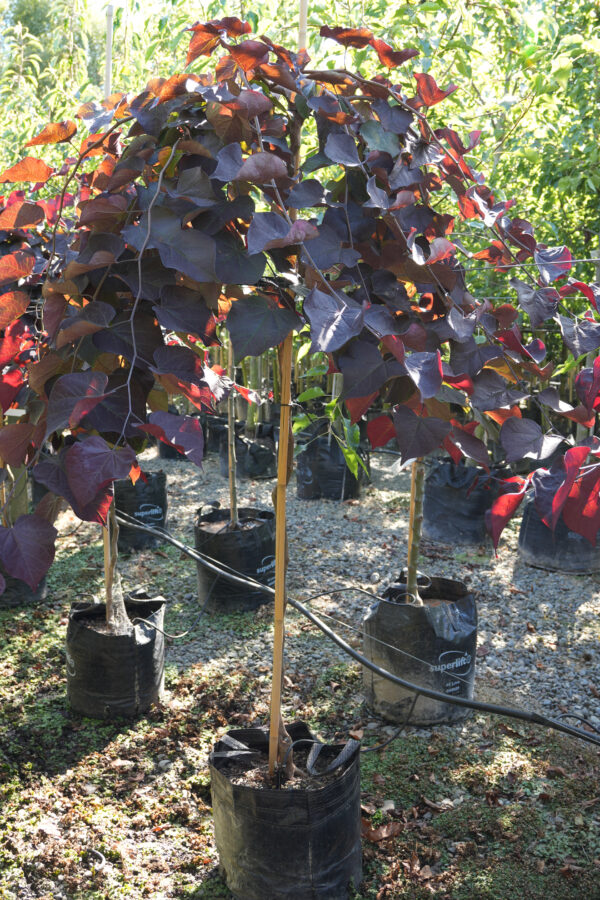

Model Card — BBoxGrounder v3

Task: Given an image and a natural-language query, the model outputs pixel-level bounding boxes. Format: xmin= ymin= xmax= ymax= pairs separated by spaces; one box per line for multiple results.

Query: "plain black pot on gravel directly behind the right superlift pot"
xmin=423 ymin=460 xmax=498 ymax=544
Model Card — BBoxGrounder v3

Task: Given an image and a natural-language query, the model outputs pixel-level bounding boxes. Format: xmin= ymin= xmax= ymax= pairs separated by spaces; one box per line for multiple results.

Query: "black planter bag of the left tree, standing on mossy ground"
xmin=66 ymin=595 xmax=165 ymax=719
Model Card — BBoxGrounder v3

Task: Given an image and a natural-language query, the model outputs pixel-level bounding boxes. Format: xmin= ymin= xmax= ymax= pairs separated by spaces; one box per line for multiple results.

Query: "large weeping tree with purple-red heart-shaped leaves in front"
xmin=0 ymin=18 xmax=600 ymax=771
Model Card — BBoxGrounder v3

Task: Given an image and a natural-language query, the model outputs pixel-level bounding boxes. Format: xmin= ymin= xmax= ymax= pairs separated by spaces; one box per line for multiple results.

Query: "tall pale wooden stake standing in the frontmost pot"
xmin=269 ymin=332 xmax=293 ymax=776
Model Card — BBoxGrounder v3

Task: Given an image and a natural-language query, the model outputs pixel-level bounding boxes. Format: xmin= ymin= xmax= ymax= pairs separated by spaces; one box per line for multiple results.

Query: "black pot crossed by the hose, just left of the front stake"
xmin=194 ymin=507 xmax=275 ymax=612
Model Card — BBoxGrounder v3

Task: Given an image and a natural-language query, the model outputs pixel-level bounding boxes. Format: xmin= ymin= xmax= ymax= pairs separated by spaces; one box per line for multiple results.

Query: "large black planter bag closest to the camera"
xmin=210 ymin=722 xmax=362 ymax=900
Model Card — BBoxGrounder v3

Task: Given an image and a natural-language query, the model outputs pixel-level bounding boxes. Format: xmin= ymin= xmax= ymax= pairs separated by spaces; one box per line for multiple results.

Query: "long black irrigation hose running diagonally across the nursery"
xmin=117 ymin=513 xmax=600 ymax=746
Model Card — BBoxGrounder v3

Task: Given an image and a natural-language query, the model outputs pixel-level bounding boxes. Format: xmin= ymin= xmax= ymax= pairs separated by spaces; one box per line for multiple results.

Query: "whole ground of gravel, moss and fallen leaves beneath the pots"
xmin=0 ymin=449 xmax=600 ymax=900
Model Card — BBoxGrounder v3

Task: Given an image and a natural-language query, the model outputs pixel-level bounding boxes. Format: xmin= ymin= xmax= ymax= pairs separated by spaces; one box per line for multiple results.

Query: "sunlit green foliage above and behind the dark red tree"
xmin=0 ymin=0 xmax=600 ymax=287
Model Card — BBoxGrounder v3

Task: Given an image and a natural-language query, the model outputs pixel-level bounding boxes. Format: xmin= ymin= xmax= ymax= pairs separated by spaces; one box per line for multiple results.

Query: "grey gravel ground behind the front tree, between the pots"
xmin=108 ymin=440 xmax=600 ymax=726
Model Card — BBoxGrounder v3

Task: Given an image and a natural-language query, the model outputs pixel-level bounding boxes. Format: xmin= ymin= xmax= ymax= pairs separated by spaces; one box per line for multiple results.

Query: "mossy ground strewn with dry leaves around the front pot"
xmin=0 ymin=502 xmax=600 ymax=900
